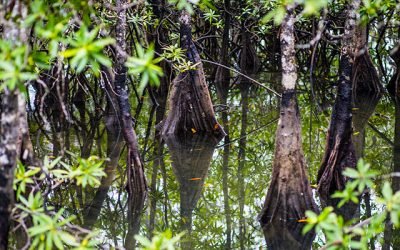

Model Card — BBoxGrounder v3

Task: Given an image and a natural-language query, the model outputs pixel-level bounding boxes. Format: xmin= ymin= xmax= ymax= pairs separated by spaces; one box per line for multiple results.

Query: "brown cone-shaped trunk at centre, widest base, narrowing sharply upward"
xmin=162 ymin=11 xmax=224 ymax=138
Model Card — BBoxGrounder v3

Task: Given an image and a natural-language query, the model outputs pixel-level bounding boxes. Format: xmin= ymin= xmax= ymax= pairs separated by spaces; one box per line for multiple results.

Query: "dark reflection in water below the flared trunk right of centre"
xmin=263 ymin=221 xmax=315 ymax=250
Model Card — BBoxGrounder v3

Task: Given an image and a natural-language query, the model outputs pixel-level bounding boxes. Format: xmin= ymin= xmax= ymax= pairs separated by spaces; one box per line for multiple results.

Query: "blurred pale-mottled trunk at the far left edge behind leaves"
xmin=0 ymin=1 xmax=34 ymax=250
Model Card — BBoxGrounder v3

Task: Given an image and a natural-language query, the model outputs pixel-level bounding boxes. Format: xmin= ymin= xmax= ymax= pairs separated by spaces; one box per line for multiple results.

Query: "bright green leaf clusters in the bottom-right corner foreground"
xmin=303 ymin=159 xmax=400 ymax=249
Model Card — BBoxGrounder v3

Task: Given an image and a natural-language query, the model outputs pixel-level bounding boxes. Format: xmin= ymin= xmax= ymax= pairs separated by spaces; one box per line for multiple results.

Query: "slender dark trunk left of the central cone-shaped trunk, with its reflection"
xmin=114 ymin=0 xmax=147 ymax=249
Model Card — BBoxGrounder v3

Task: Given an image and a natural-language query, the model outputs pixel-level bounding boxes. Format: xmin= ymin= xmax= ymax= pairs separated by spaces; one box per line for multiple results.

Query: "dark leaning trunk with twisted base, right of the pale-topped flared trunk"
xmin=318 ymin=0 xmax=360 ymax=218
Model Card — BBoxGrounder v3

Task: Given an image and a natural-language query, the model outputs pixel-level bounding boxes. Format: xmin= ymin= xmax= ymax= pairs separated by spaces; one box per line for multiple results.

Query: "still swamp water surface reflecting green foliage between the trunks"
xmin=25 ymin=74 xmax=394 ymax=249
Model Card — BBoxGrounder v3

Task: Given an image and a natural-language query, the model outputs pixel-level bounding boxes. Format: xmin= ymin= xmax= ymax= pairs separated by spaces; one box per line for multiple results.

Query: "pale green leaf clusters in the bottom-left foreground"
xmin=14 ymin=156 xmax=105 ymax=250
